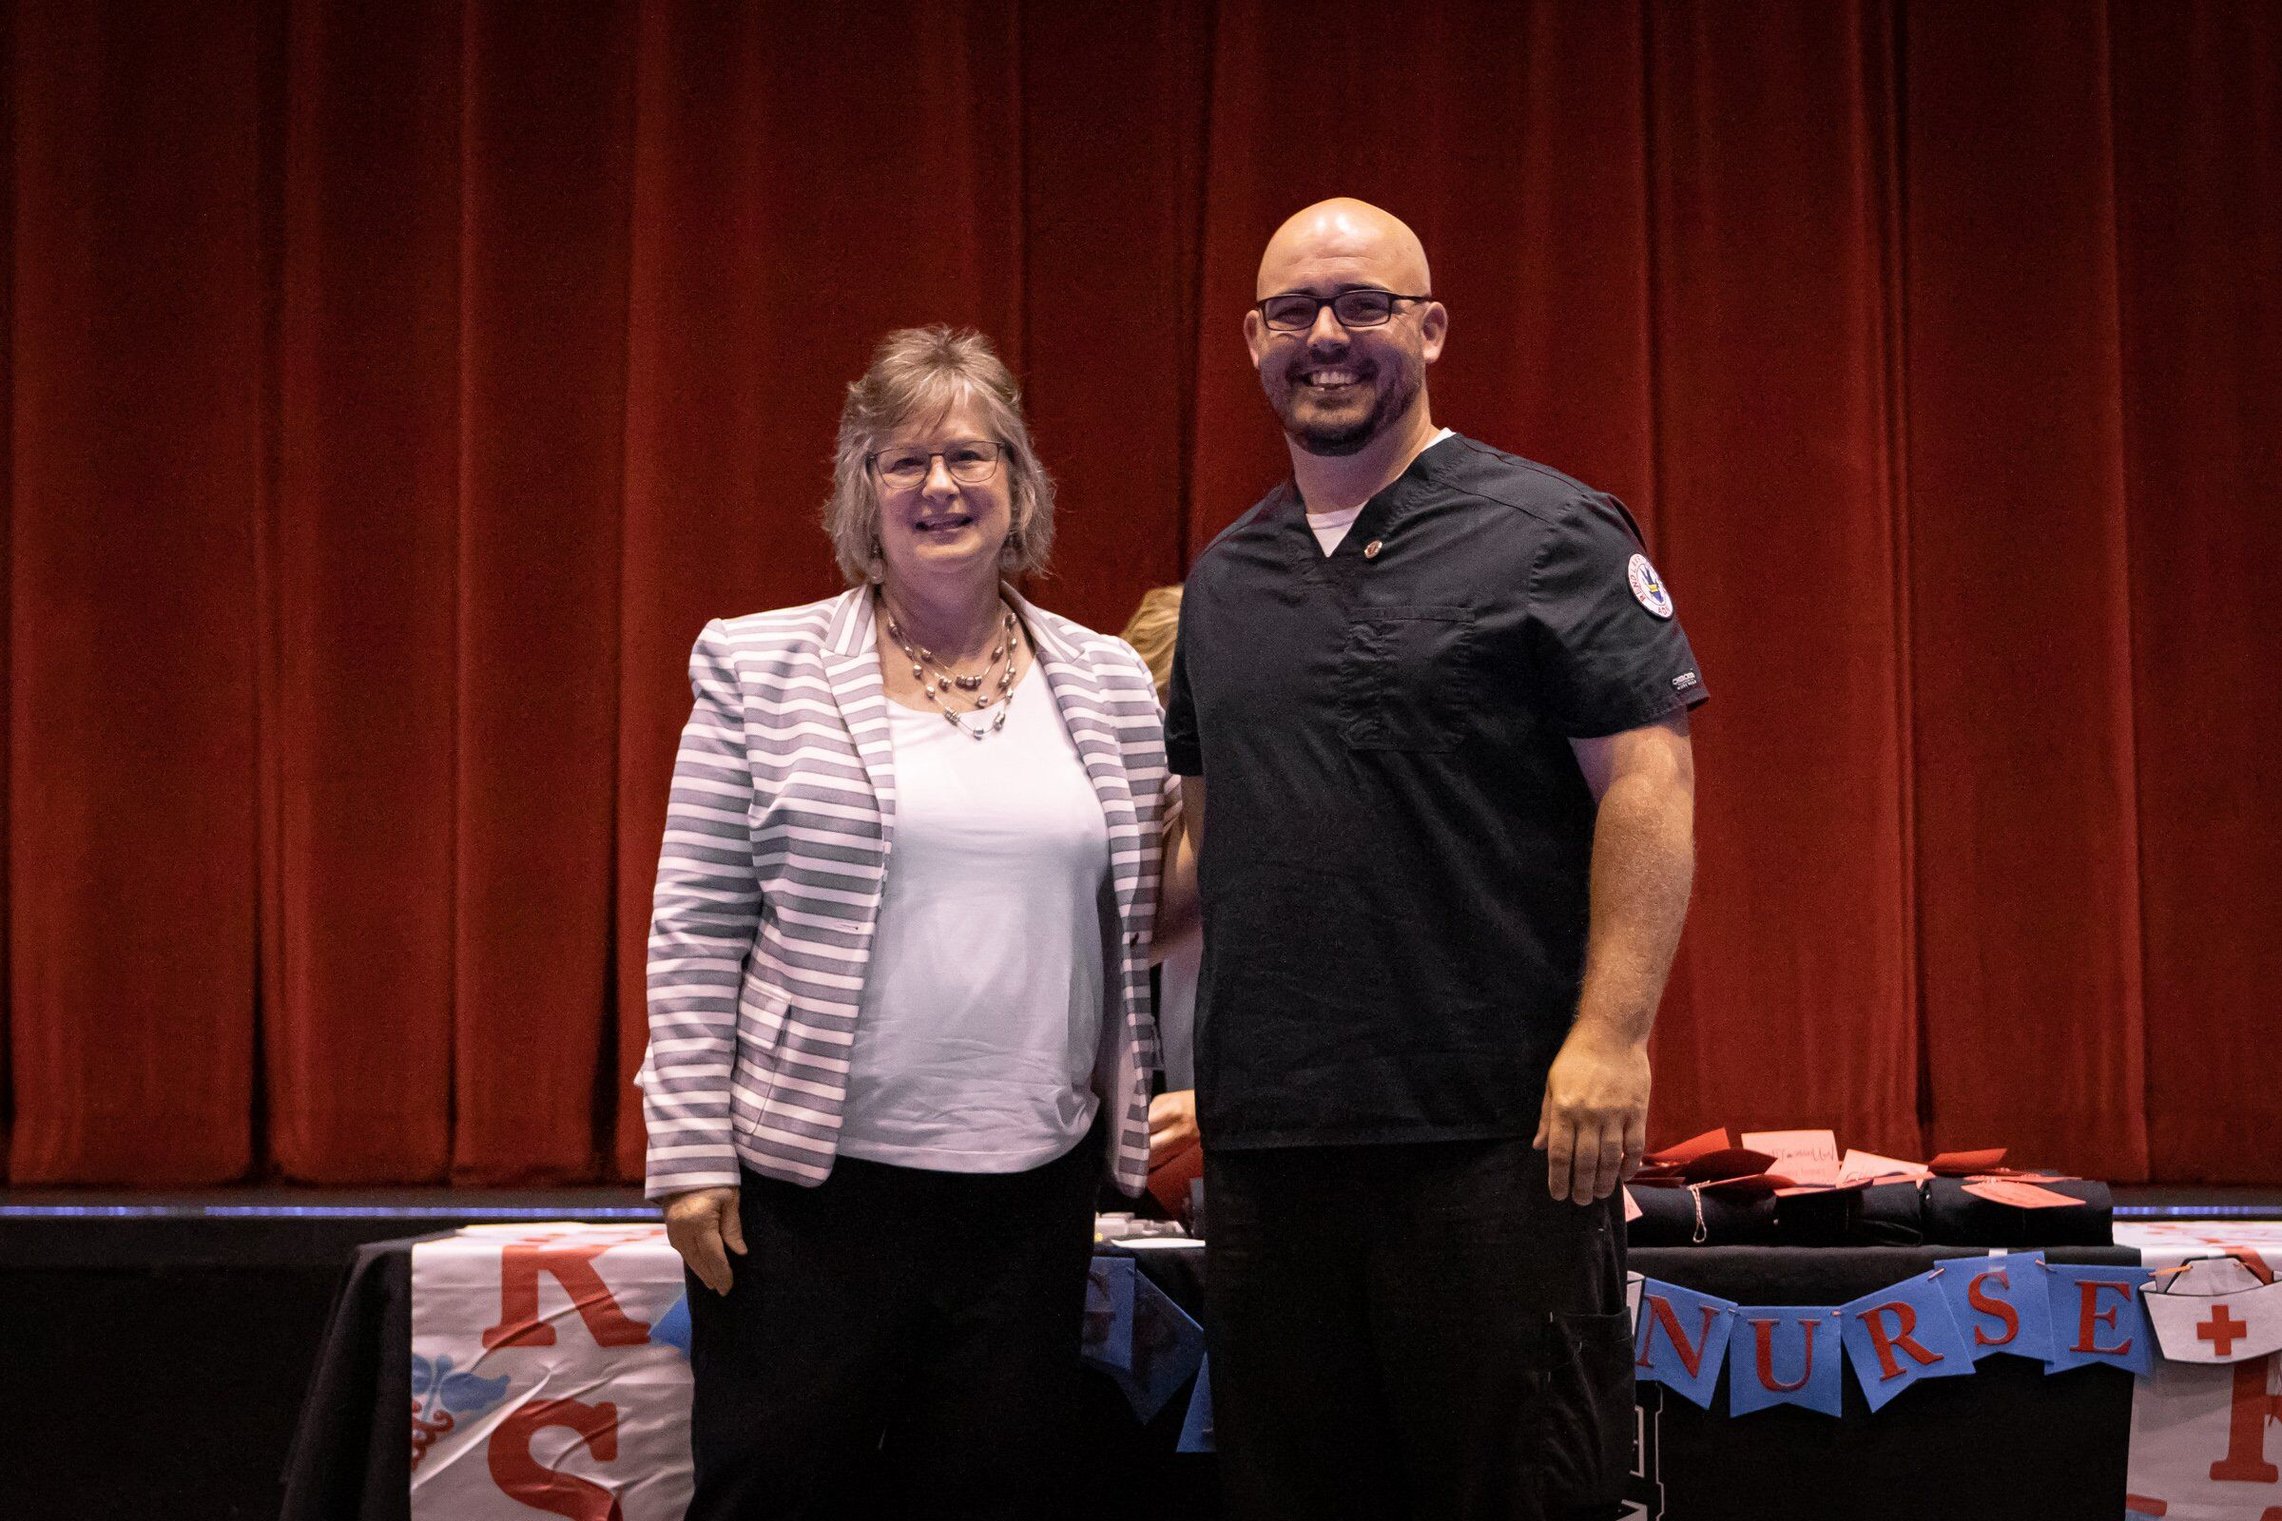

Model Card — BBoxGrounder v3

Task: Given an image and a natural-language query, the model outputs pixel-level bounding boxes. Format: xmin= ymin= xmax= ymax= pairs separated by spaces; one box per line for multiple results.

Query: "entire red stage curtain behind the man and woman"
xmin=0 ymin=0 xmax=2282 ymax=1184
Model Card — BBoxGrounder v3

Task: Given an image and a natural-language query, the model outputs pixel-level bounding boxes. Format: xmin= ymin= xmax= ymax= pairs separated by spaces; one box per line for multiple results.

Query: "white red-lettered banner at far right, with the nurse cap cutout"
xmin=2115 ymin=1220 xmax=2282 ymax=1521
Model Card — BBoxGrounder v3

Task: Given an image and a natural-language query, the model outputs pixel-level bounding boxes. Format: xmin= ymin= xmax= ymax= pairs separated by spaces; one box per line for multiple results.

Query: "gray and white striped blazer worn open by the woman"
xmin=634 ymin=588 xmax=1175 ymax=1199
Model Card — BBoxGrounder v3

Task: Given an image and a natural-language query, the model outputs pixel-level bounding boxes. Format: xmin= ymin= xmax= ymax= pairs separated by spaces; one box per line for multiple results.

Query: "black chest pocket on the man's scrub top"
xmin=1340 ymin=607 xmax=1474 ymax=750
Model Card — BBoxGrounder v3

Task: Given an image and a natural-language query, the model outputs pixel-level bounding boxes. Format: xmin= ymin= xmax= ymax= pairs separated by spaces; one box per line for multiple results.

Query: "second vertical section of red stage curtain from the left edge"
xmin=260 ymin=0 xmax=461 ymax=1184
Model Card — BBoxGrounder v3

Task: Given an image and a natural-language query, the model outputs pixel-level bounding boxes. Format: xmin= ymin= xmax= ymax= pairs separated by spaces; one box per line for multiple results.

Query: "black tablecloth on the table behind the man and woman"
xmin=283 ymin=1241 xmax=2138 ymax=1521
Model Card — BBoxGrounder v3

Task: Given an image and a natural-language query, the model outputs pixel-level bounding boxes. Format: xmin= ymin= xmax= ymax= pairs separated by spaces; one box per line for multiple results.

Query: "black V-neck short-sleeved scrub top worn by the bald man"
xmin=1166 ymin=436 xmax=1705 ymax=1147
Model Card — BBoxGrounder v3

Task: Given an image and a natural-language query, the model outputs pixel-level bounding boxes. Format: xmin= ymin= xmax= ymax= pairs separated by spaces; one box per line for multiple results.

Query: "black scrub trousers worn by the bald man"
xmin=1205 ymin=1138 xmax=1634 ymax=1521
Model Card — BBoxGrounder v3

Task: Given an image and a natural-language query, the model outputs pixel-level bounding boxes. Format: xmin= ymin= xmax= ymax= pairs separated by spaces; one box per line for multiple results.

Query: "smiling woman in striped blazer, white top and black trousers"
xmin=637 ymin=326 xmax=1173 ymax=1521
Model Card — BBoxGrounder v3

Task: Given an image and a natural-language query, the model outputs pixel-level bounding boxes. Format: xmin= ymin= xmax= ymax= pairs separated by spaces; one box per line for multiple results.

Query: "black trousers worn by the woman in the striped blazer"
xmin=687 ymin=1124 xmax=1102 ymax=1521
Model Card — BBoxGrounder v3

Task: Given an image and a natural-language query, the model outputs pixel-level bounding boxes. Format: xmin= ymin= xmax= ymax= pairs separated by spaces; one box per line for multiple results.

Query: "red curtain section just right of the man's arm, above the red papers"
xmin=1648 ymin=0 xmax=1921 ymax=1154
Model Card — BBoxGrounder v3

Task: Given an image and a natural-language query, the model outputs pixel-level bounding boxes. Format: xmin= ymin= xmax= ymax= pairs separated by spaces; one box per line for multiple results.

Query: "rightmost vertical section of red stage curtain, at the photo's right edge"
xmin=2109 ymin=0 xmax=2282 ymax=1184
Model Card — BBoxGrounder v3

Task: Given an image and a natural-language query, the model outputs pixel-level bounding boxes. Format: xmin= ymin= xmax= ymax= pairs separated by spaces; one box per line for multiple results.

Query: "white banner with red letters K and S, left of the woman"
xmin=411 ymin=1225 xmax=689 ymax=1521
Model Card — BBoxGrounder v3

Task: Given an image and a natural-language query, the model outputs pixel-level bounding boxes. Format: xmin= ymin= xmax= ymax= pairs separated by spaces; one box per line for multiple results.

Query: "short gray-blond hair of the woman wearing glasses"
xmin=824 ymin=322 xmax=1054 ymax=586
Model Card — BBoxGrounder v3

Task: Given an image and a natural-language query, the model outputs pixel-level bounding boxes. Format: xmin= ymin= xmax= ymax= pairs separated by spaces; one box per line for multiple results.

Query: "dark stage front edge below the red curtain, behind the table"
xmin=0 ymin=1188 xmax=2282 ymax=1521
